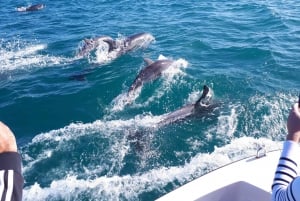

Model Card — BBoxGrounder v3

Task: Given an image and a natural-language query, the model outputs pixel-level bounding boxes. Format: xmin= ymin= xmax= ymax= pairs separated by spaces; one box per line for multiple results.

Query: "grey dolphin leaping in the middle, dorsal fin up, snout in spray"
xmin=128 ymin=59 xmax=174 ymax=94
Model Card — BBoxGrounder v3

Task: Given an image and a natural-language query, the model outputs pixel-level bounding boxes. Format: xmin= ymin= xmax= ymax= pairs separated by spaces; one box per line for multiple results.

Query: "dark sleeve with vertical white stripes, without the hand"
xmin=0 ymin=152 xmax=24 ymax=201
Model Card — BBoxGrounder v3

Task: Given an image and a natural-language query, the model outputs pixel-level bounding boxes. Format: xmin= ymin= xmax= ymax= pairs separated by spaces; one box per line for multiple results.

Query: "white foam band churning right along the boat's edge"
xmin=24 ymin=137 xmax=281 ymax=200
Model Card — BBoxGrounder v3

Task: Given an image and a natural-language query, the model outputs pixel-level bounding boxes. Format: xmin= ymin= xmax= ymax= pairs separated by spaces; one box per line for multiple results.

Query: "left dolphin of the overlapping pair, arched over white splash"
xmin=76 ymin=36 xmax=116 ymax=57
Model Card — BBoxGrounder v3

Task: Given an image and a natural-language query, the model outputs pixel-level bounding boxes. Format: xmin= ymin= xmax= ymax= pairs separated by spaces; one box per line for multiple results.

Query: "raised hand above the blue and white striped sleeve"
xmin=286 ymin=103 xmax=300 ymax=142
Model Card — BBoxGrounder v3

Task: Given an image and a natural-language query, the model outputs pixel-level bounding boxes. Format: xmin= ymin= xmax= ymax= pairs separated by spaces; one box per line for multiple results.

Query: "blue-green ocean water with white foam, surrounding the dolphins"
xmin=0 ymin=0 xmax=300 ymax=201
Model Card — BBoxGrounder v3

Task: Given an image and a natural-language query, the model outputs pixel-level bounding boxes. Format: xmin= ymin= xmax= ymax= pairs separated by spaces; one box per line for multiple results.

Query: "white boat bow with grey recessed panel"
xmin=156 ymin=150 xmax=281 ymax=201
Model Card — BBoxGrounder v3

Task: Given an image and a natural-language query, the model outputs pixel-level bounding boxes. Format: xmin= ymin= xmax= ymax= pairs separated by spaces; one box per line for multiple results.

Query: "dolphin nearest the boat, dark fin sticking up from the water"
xmin=158 ymin=85 xmax=212 ymax=126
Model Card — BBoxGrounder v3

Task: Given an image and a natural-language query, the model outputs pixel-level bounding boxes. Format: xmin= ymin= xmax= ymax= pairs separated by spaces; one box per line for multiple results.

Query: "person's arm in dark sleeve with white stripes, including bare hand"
xmin=0 ymin=122 xmax=24 ymax=201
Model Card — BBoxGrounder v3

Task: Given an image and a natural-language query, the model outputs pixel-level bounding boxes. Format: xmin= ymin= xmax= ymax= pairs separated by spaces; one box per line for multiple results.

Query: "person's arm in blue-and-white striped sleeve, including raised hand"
xmin=272 ymin=104 xmax=300 ymax=201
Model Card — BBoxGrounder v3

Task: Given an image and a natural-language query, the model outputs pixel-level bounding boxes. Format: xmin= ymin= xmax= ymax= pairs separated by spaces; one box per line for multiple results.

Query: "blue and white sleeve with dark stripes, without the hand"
xmin=272 ymin=141 xmax=300 ymax=201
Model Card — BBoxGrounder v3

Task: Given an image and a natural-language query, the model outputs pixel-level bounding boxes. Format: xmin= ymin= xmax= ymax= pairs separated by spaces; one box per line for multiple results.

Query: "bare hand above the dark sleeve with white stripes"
xmin=0 ymin=121 xmax=17 ymax=153
